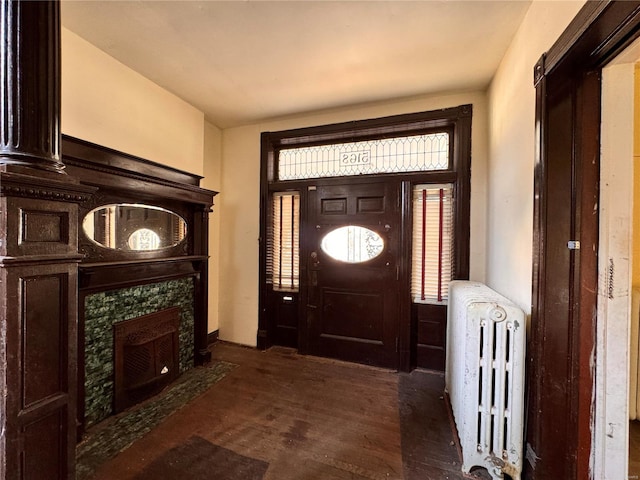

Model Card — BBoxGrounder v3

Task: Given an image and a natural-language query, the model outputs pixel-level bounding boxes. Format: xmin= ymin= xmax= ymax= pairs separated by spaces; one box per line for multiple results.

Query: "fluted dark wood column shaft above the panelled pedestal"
xmin=0 ymin=0 xmax=64 ymax=172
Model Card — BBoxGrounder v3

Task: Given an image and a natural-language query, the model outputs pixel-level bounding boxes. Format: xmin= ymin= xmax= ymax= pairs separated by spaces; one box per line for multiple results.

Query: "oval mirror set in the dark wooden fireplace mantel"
xmin=82 ymin=203 xmax=187 ymax=251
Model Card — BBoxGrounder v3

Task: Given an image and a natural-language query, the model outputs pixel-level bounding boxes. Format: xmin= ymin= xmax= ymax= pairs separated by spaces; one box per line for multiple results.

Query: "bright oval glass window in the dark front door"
xmin=320 ymin=225 xmax=384 ymax=263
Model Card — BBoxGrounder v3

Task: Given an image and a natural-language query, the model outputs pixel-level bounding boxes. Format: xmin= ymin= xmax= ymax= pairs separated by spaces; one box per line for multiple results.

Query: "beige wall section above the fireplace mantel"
xmin=61 ymin=28 xmax=204 ymax=175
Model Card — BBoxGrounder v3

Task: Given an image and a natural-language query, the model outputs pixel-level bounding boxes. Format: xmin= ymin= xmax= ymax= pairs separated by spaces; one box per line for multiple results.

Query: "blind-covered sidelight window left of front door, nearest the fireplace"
xmin=267 ymin=192 xmax=300 ymax=291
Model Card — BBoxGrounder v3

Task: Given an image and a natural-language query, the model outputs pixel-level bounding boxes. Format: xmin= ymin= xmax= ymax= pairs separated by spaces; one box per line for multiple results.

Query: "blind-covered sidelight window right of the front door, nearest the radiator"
xmin=411 ymin=184 xmax=454 ymax=304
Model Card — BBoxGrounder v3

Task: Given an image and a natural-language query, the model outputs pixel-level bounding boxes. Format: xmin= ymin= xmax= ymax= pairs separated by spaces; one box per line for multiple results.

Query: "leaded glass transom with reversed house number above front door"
xmin=278 ymin=132 xmax=449 ymax=180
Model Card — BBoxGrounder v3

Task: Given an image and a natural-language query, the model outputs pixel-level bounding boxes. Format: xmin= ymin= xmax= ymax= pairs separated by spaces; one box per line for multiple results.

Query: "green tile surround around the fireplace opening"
xmin=84 ymin=277 xmax=194 ymax=427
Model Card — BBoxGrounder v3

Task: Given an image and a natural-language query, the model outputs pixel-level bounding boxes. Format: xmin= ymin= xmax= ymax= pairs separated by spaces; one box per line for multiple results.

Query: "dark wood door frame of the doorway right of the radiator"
xmin=525 ymin=1 xmax=640 ymax=480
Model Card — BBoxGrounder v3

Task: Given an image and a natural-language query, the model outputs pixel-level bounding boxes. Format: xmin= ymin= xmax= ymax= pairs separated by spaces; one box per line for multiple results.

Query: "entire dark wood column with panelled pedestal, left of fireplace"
xmin=0 ymin=0 xmax=93 ymax=480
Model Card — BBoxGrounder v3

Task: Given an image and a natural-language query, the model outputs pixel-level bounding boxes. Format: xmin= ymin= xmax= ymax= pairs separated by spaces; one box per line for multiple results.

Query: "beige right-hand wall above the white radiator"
xmin=486 ymin=1 xmax=584 ymax=313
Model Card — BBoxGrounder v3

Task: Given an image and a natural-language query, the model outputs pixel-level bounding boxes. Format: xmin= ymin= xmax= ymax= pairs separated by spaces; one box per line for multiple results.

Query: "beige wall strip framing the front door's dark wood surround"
xmin=219 ymin=92 xmax=488 ymax=345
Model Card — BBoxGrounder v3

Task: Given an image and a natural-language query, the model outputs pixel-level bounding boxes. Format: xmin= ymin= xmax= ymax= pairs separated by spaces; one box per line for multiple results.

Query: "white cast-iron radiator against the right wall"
xmin=445 ymin=281 xmax=526 ymax=480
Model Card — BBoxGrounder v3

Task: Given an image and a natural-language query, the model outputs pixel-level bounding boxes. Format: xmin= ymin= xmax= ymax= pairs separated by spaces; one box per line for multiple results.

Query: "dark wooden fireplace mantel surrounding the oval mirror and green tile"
xmin=61 ymin=136 xmax=217 ymax=435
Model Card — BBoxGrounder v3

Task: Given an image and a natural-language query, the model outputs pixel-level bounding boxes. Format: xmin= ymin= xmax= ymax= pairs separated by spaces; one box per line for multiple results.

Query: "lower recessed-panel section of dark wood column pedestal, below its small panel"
xmin=0 ymin=260 xmax=77 ymax=479
